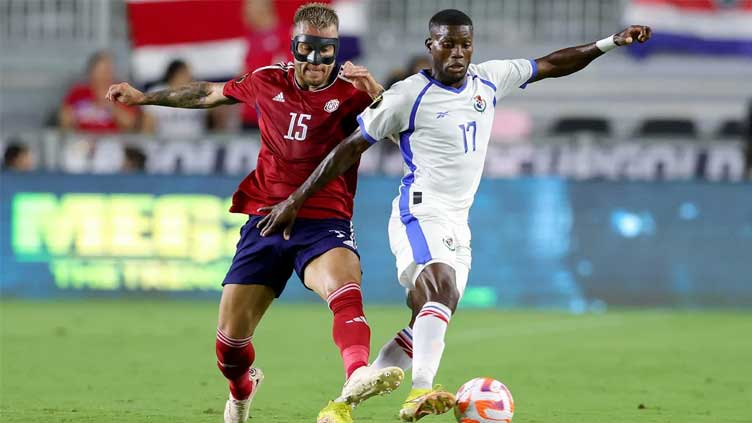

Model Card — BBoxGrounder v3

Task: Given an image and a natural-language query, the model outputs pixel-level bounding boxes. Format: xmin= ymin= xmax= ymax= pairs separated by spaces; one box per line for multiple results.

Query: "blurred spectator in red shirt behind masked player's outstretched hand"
xmin=58 ymin=51 xmax=138 ymax=133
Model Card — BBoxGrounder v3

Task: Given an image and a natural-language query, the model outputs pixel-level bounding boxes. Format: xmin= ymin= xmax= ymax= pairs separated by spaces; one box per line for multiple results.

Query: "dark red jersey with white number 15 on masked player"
xmin=224 ymin=63 xmax=371 ymax=219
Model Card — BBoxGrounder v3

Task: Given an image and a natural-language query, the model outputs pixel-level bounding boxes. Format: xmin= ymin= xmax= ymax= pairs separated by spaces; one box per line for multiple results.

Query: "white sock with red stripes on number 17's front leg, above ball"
xmin=413 ymin=302 xmax=452 ymax=389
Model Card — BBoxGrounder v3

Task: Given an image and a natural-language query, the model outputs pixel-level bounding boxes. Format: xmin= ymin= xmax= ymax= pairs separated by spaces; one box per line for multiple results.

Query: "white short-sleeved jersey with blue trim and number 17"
xmin=358 ymin=59 xmax=537 ymax=222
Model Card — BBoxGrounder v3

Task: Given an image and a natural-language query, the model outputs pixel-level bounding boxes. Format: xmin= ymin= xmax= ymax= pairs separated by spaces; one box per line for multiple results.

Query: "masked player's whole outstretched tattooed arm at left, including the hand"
xmin=107 ymin=82 xmax=237 ymax=109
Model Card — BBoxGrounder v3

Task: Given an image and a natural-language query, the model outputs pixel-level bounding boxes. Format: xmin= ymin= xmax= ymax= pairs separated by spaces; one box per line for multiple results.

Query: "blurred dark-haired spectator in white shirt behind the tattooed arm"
xmin=141 ymin=60 xmax=220 ymax=139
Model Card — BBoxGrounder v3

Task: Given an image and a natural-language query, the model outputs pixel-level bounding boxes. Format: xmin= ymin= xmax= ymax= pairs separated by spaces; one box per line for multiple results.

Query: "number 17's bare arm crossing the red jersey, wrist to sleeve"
xmin=291 ymin=129 xmax=371 ymax=205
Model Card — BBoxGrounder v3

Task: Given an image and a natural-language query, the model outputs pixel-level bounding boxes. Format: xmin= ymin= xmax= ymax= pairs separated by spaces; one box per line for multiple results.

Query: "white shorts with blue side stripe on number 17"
xmin=389 ymin=199 xmax=472 ymax=297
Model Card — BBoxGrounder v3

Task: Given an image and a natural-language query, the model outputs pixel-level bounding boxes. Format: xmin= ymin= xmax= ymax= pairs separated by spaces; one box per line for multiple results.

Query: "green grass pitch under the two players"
xmin=0 ymin=300 xmax=752 ymax=423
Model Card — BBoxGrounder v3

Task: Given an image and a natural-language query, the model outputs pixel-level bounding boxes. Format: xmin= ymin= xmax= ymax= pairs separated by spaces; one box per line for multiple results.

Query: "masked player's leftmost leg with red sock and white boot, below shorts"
xmin=216 ymin=284 xmax=275 ymax=423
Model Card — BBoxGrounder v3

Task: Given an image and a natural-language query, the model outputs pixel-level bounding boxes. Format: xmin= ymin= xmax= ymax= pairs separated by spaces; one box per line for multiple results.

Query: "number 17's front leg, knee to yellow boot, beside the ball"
xmin=400 ymin=263 xmax=460 ymax=422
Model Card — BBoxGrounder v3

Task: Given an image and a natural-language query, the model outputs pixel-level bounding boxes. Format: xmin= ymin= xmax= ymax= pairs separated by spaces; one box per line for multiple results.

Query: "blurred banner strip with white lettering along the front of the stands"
xmin=0 ymin=130 xmax=745 ymax=181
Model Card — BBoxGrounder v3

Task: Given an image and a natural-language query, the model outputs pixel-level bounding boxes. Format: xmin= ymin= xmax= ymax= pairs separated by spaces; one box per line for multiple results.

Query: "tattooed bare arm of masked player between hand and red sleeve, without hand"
xmin=146 ymin=82 xmax=234 ymax=109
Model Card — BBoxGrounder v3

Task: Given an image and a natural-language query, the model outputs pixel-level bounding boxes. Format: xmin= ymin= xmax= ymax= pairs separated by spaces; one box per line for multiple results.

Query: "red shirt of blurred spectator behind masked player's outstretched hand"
xmin=63 ymin=84 xmax=135 ymax=133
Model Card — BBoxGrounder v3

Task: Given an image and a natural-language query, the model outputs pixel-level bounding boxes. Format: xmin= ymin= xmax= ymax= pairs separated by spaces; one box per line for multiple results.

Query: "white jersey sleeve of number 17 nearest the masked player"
xmin=357 ymin=83 xmax=410 ymax=144
